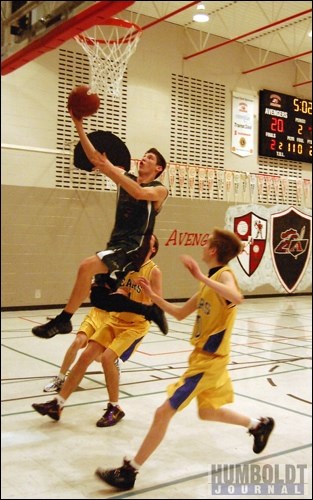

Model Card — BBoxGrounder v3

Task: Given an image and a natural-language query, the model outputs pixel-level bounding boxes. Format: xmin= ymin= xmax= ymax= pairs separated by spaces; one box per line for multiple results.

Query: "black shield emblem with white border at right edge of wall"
xmin=271 ymin=207 xmax=312 ymax=293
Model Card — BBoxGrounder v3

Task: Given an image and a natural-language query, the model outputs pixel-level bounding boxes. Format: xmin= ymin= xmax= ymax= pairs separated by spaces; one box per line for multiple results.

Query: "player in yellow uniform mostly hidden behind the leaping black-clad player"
xmin=32 ymin=235 xmax=162 ymax=427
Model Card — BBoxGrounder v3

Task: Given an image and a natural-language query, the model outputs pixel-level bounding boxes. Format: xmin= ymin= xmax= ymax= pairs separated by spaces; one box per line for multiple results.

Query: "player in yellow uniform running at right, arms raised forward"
xmin=96 ymin=228 xmax=274 ymax=490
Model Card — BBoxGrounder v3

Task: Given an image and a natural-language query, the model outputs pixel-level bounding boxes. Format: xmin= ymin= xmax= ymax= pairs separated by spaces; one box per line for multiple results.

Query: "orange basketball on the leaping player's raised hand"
xmin=67 ymin=85 xmax=100 ymax=119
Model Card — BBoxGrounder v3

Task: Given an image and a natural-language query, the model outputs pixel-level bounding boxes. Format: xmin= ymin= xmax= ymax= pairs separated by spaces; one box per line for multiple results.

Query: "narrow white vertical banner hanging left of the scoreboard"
xmin=231 ymin=92 xmax=254 ymax=156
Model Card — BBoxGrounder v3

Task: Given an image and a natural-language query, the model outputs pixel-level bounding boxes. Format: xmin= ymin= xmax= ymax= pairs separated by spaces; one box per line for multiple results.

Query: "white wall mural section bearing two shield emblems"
xmin=225 ymin=204 xmax=312 ymax=294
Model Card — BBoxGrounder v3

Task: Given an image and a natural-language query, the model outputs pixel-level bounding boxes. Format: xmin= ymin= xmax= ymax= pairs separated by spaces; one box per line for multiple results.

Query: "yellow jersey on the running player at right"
xmin=191 ymin=266 xmax=239 ymax=356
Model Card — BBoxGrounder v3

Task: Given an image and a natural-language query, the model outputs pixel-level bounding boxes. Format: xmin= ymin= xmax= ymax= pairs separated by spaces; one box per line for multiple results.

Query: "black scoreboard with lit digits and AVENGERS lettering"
xmin=259 ymin=90 xmax=312 ymax=163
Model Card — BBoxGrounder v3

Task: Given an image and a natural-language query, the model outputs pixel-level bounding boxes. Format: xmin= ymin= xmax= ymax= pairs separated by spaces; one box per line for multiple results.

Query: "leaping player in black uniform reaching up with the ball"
xmin=32 ymin=114 xmax=168 ymax=338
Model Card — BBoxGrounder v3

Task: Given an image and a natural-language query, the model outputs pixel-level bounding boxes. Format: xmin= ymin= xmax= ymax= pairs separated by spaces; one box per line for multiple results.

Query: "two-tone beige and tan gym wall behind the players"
xmin=1 ymin=17 xmax=312 ymax=308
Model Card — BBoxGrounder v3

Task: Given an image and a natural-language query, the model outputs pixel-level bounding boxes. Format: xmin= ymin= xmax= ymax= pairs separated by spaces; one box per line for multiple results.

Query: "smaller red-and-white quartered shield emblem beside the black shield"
xmin=234 ymin=212 xmax=267 ymax=276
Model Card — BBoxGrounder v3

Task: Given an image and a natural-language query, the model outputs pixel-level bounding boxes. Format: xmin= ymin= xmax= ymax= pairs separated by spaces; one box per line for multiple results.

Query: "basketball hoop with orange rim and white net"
xmin=74 ymin=17 xmax=142 ymax=98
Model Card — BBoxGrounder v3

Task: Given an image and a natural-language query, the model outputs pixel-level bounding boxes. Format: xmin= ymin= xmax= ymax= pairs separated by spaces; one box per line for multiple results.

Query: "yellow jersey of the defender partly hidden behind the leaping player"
xmin=111 ymin=259 xmax=157 ymax=323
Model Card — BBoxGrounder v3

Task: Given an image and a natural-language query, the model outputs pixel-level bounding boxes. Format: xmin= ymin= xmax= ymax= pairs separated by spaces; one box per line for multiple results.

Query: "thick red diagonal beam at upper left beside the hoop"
xmin=1 ymin=0 xmax=134 ymax=75
